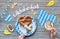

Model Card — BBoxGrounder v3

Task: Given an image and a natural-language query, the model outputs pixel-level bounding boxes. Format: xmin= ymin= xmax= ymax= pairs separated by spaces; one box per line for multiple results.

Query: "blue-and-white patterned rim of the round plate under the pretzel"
xmin=15 ymin=18 xmax=37 ymax=36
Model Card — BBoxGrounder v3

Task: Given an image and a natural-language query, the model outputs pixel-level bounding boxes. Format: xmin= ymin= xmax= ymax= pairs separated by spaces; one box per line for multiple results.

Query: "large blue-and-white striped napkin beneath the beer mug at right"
xmin=37 ymin=10 xmax=56 ymax=28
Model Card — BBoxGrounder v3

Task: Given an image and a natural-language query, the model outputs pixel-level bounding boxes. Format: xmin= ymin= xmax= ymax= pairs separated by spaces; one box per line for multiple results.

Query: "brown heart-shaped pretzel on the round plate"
xmin=18 ymin=16 xmax=32 ymax=26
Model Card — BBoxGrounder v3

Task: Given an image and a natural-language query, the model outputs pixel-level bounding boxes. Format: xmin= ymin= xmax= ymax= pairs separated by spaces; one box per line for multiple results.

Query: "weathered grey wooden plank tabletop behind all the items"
xmin=0 ymin=0 xmax=60 ymax=39
